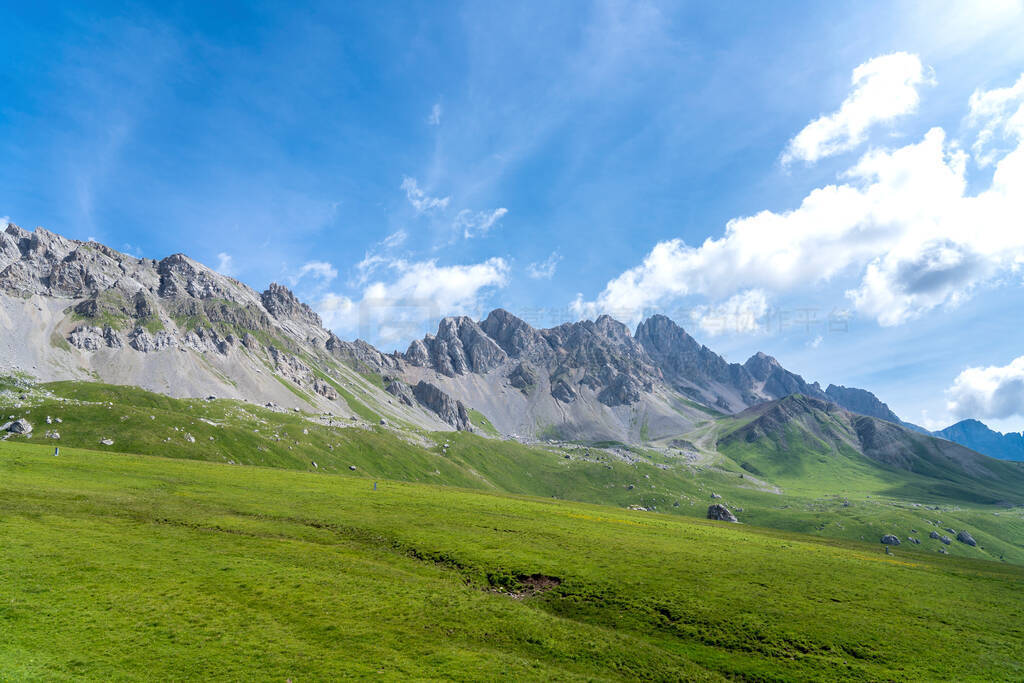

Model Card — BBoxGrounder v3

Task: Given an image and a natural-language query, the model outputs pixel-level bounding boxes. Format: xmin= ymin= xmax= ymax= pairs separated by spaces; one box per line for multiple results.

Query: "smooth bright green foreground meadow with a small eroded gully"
xmin=6 ymin=442 xmax=1024 ymax=681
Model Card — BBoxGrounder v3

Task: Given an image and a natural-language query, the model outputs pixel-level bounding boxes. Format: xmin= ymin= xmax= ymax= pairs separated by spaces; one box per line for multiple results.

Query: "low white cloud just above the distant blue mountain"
xmin=946 ymin=355 xmax=1024 ymax=420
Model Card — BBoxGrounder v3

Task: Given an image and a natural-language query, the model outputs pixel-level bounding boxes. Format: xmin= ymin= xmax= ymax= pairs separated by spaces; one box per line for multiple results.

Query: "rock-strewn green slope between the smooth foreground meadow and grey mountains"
xmin=6 ymin=380 xmax=1024 ymax=564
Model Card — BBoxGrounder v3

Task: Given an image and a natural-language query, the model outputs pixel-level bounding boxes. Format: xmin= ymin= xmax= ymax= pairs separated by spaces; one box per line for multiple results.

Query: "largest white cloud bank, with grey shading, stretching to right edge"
xmin=574 ymin=70 xmax=1024 ymax=326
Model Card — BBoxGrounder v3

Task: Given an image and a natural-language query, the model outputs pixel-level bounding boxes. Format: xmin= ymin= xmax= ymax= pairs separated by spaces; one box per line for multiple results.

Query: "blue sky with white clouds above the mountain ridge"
xmin=0 ymin=0 xmax=1024 ymax=431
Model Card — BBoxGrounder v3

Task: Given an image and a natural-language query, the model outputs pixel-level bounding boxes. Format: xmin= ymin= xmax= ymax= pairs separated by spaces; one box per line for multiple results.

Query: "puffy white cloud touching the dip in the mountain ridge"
xmin=316 ymin=258 xmax=509 ymax=343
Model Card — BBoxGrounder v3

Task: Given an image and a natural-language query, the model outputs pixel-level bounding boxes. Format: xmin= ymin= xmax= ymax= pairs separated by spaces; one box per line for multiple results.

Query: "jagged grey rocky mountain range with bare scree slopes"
xmin=0 ymin=224 xmax=1024 ymax=459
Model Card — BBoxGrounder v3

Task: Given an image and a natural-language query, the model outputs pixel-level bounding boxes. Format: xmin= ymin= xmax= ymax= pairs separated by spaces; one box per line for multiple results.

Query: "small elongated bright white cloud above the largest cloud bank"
xmin=782 ymin=52 xmax=930 ymax=164
